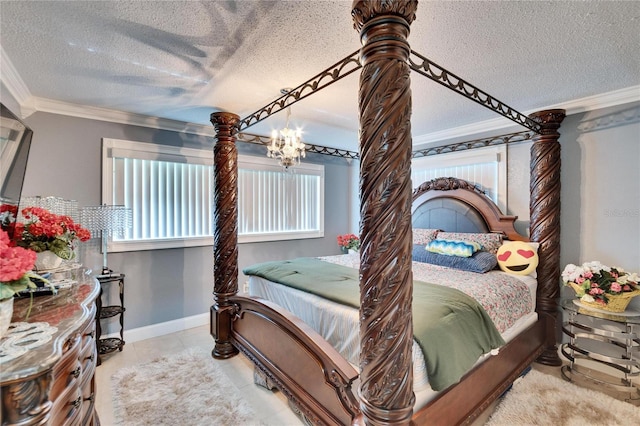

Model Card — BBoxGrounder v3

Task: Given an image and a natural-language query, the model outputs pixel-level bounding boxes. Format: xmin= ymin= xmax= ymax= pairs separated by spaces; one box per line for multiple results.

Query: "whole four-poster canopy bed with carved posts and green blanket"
xmin=211 ymin=0 xmax=564 ymax=425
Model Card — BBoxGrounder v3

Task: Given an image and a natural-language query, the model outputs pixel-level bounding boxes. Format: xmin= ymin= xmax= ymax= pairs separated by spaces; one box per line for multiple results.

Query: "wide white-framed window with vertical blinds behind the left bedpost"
xmin=102 ymin=139 xmax=324 ymax=251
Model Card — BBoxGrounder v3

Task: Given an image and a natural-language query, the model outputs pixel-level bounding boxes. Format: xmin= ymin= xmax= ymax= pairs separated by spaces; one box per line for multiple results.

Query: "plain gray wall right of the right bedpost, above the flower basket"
xmin=560 ymin=102 xmax=640 ymax=282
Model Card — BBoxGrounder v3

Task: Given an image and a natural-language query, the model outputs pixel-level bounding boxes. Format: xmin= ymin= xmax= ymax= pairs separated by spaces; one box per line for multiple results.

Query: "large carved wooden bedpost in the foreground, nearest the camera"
xmin=352 ymin=0 xmax=418 ymax=425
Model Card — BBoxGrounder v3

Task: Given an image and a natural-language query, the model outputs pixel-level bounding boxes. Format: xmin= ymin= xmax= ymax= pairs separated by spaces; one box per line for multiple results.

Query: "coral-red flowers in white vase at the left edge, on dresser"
xmin=0 ymin=230 xmax=55 ymax=337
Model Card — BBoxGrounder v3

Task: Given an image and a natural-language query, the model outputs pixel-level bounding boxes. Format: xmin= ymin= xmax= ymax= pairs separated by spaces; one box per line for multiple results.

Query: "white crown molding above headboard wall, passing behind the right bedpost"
xmin=413 ymin=86 xmax=640 ymax=146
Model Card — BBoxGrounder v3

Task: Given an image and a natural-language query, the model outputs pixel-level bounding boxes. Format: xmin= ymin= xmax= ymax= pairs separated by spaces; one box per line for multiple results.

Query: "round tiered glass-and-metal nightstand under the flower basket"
xmin=561 ymin=299 xmax=640 ymax=399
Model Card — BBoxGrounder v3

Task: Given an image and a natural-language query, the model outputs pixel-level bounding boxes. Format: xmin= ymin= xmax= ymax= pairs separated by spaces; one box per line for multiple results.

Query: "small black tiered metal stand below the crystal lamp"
xmin=96 ymin=273 xmax=126 ymax=365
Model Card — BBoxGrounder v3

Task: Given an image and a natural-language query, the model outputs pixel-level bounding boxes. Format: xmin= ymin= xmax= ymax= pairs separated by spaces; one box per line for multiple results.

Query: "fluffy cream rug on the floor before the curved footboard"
xmin=111 ymin=349 xmax=260 ymax=426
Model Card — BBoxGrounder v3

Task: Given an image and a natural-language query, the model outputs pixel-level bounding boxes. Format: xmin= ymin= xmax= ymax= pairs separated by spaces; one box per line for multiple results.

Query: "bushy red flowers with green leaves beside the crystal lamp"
xmin=13 ymin=207 xmax=91 ymax=260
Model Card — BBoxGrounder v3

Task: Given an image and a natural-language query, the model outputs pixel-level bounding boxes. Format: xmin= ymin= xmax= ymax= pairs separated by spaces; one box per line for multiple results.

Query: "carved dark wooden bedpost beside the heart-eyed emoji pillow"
xmin=529 ymin=109 xmax=565 ymax=365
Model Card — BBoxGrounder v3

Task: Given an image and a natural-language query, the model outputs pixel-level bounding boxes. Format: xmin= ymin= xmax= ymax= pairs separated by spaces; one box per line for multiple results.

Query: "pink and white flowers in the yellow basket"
xmin=562 ymin=261 xmax=640 ymax=306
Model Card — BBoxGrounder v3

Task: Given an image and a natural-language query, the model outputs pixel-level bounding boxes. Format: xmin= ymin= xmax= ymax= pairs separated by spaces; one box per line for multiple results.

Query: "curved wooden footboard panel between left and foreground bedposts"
xmin=229 ymin=296 xmax=362 ymax=425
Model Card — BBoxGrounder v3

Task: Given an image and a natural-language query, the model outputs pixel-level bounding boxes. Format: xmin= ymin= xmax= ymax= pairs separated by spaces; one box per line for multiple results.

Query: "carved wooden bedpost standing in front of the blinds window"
xmin=211 ymin=112 xmax=240 ymax=358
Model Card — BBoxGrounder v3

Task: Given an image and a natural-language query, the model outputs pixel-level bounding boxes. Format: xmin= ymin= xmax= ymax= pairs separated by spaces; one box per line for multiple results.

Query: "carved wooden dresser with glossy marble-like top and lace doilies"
xmin=0 ymin=268 xmax=100 ymax=426
